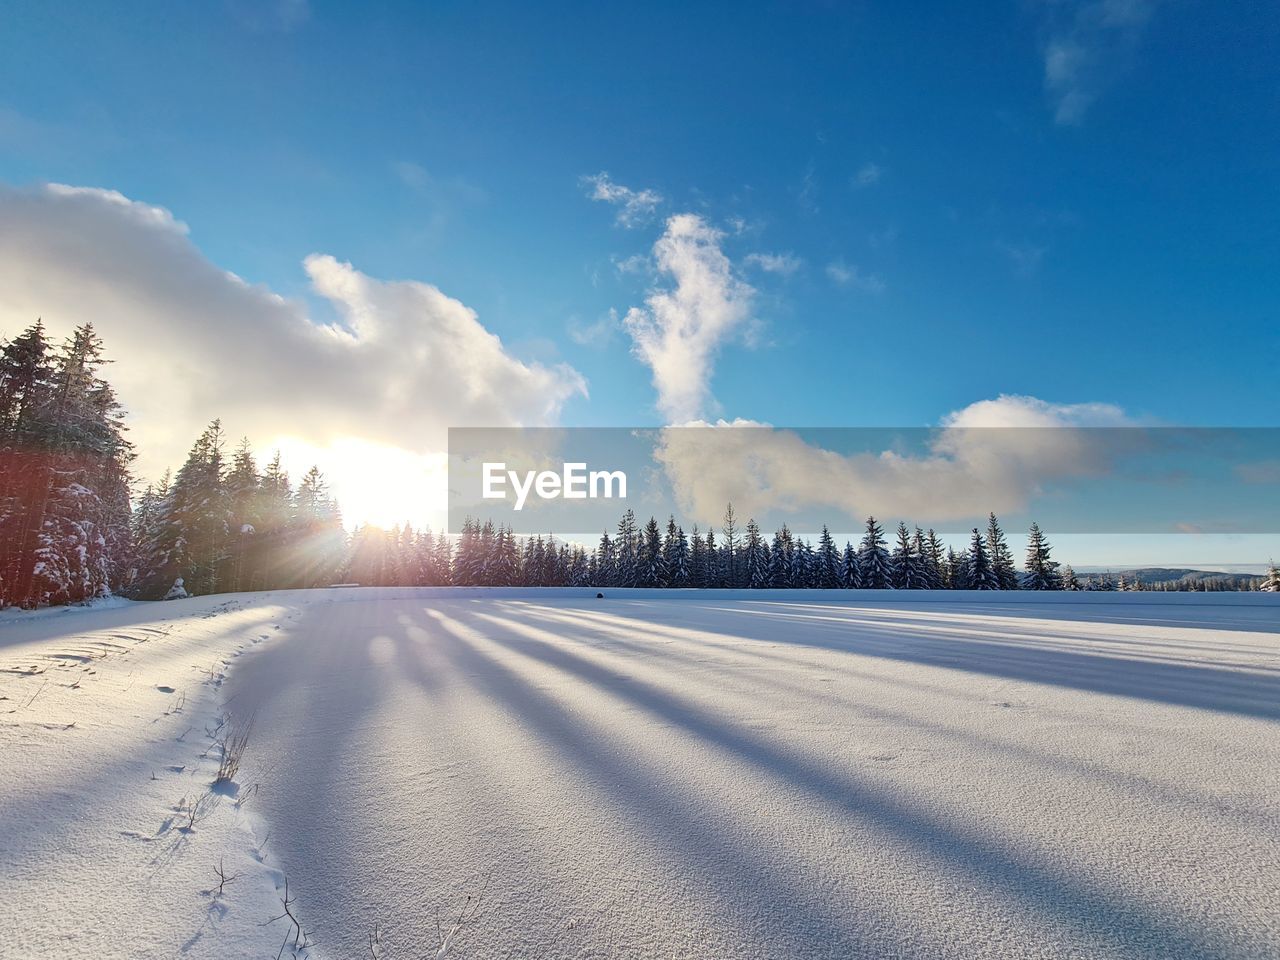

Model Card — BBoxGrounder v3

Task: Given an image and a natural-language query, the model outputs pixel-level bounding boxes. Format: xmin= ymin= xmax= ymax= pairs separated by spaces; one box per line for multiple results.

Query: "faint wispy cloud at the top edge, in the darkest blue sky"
xmin=1043 ymin=0 xmax=1161 ymax=125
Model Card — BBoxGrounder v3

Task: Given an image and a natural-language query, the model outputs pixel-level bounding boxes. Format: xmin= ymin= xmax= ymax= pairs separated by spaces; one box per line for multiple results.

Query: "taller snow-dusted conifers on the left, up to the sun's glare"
xmin=0 ymin=321 xmax=349 ymax=608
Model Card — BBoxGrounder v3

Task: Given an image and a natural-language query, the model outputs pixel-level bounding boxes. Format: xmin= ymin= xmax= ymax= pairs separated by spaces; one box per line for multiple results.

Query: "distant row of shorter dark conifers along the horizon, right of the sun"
xmin=346 ymin=506 xmax=1280 ymax=591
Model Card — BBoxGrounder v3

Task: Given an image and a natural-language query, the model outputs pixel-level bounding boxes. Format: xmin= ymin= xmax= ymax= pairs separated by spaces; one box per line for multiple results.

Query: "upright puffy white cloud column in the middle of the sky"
xmin=623 ymin=214 xmax=755 ymax=421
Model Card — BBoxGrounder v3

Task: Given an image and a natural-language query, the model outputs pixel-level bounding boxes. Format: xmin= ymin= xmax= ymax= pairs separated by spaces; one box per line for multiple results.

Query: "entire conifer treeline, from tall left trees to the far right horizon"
xmin=0 ymin=321 xmax=1280 ymax=607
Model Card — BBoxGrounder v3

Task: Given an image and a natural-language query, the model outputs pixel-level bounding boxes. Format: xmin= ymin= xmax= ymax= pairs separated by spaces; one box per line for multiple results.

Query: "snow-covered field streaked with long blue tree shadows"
xmin=0 ymin=589 xmax=1280 ymax=960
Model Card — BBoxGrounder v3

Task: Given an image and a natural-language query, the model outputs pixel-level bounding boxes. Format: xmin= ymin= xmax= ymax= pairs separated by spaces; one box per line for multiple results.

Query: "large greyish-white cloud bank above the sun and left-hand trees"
xmin=0 ymin=184 xmax=586 ymax=522
